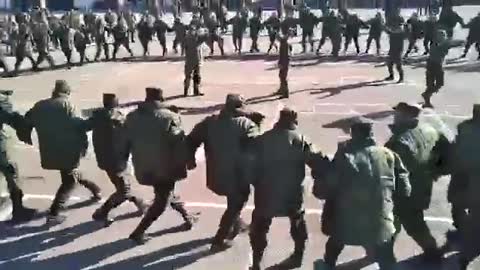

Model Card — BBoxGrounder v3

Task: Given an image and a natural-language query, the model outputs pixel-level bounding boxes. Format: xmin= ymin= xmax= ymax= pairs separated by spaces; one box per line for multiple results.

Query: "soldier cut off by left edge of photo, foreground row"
xmin=0 ymin=90 xmax=37 ymax=223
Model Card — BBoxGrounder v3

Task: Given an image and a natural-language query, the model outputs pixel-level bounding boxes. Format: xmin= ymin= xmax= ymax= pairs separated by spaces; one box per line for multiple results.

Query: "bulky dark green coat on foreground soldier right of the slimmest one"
xmin=122 ymin=101 xmax=187 ymax=185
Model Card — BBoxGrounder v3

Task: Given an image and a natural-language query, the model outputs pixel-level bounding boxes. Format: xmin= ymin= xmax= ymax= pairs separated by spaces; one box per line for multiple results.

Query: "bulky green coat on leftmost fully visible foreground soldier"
xmin=25 ymin=94 xmax=88 ymax=170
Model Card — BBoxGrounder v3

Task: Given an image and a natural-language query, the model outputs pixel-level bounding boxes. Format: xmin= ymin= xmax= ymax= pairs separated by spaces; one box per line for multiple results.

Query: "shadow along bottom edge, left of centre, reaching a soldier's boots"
xmin=102 ymin=238 xmax=214 ymax=270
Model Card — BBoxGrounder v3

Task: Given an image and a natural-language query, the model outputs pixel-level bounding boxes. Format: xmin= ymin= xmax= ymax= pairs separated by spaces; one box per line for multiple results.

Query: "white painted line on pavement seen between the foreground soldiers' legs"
xmin=18 ymin=194 xmax=453 ymax=224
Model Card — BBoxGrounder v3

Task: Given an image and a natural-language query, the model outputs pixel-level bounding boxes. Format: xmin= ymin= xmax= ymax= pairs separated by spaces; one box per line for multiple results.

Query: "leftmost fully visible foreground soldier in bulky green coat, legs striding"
xmin=19 ymin=80 xmax=101 ymax=225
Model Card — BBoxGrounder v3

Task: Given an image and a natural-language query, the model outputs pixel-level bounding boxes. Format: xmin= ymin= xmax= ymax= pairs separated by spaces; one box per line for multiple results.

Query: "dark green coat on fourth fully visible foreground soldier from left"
xmin=188 ymin=110 xmax=259 ymax=196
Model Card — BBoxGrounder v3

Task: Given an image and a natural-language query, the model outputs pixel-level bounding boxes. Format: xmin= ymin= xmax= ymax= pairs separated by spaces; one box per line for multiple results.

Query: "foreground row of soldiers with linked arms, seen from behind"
xmin=0 ymin=79 xmax=480 ymax=270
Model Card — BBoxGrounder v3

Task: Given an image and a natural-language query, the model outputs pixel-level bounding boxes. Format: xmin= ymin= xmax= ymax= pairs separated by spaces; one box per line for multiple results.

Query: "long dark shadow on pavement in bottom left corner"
xmin=0 ymin=222 xmax=102 ymax=269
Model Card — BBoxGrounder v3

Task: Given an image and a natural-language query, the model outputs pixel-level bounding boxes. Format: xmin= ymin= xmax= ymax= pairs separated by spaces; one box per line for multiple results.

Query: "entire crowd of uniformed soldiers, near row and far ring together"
xmin=0 ymin=2 xmax=480 ymax=270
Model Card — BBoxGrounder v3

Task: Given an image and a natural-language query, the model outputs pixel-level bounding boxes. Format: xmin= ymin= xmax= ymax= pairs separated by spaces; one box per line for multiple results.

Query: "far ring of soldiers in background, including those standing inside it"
xmin=0 ymin=5 xmax=480 ymax=102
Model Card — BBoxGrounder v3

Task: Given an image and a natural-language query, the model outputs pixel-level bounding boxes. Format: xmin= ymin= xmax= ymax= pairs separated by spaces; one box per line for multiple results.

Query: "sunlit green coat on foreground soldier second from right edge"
xmin=385 ymin=122 xmax=448 ymax=210
